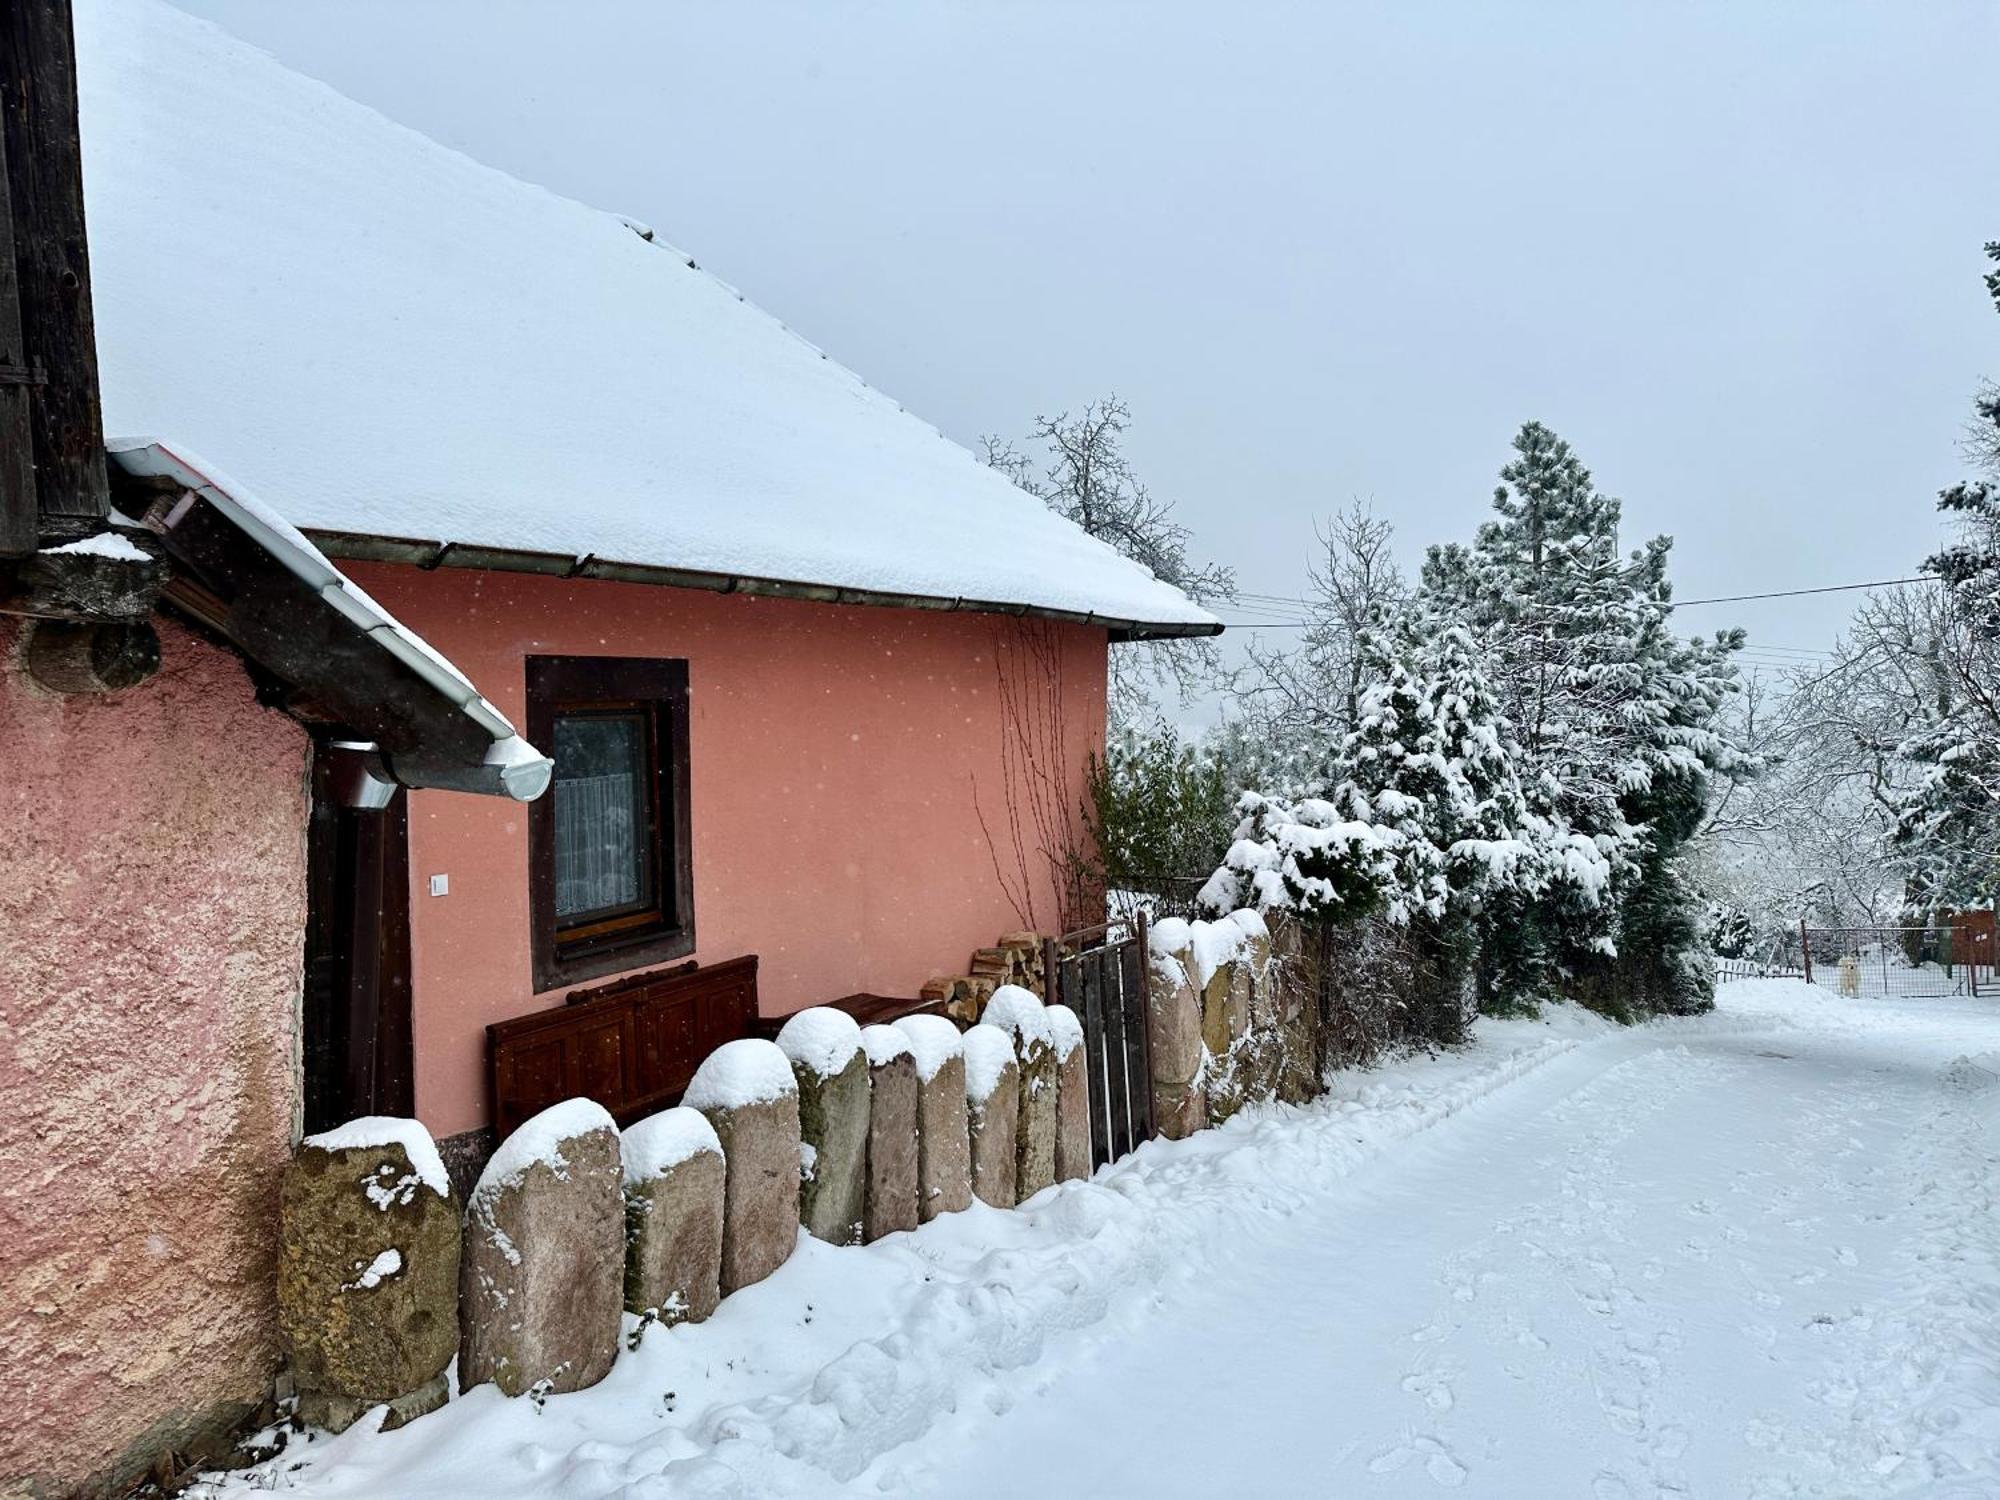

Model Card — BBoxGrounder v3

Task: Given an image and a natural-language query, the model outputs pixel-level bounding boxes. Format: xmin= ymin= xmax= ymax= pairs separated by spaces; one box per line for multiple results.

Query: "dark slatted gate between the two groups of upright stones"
xmin=1042 ymin=912 xmax=1152 ymax=1170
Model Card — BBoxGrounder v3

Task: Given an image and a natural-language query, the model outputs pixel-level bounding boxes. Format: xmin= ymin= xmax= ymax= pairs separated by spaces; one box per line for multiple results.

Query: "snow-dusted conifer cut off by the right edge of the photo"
xmin=1896 ymin=242 xmax=2000 ymax=920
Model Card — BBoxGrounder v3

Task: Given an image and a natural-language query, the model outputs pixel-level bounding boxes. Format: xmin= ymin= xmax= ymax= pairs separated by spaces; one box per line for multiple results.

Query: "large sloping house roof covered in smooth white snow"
xmin=76 ymin=0 xmax=1214 ymax=634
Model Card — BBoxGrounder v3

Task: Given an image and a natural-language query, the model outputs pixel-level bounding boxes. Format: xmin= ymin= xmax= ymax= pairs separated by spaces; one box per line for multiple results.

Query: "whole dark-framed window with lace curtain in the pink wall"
xmin=528 ymin=656 xmax=694 ymax=990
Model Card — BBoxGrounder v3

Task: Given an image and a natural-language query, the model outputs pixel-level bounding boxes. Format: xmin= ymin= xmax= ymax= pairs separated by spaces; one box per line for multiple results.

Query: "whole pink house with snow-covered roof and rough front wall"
xmin=0 ymin=0 xmax=1218 ymax=1496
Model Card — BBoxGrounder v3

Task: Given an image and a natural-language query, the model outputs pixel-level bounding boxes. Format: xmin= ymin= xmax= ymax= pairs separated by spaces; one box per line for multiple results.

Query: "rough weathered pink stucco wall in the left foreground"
xmin=0 ymin=618 xmax=306 ymax=1500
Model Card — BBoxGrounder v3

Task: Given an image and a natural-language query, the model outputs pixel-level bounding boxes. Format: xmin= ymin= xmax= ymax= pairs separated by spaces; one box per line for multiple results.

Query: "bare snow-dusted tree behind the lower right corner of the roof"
xmin=984 ymin=396 xmax=1236 ymax=726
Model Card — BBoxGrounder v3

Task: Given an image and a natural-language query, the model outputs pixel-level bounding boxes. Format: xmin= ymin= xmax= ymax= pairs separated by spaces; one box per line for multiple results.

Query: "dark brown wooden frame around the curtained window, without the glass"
xmin=528 ymin=656 xmax=694 ymax=994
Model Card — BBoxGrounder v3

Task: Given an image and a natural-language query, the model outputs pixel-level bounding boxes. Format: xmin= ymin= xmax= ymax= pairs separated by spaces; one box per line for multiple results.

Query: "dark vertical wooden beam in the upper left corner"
xmin=0 ymin=0 xmax=110 ymax=546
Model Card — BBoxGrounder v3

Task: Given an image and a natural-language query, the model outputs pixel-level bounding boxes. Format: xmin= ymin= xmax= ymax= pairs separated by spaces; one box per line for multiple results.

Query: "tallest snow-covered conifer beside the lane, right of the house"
xmin=1420 ymin=422 xmax=1750 ymax=1014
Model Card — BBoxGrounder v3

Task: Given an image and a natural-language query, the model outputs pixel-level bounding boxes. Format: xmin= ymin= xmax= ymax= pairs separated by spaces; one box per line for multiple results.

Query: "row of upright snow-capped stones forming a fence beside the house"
xmin=266 ymin=912 xmax=1318 ymax=1464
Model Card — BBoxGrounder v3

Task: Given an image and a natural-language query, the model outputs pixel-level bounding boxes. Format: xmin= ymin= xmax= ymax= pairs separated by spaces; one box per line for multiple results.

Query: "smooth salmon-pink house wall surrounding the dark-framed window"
xmin=334 ymin=564 xmax=1106 ymax=1136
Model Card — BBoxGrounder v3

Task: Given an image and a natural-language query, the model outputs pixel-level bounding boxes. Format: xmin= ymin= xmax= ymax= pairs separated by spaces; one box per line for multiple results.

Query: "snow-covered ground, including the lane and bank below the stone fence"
xmin=207 ymin=980 xmax=2000 ymax=1500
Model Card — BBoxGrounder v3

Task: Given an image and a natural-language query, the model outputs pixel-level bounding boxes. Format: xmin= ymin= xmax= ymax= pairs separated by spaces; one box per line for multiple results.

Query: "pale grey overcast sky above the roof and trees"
xmin=180 ymin=0 xmax=2000 ymax=680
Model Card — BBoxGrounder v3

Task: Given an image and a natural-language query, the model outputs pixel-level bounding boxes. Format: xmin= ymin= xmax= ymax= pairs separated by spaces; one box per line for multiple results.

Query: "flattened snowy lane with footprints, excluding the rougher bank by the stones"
xmin=922 ymin=1002 xmax=2000 ymax=1500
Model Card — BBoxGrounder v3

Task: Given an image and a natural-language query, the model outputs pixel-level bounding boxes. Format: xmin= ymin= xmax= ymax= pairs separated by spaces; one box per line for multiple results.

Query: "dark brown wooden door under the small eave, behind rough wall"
xmin=304 ymin=748 xmax=416 ymax=1134
